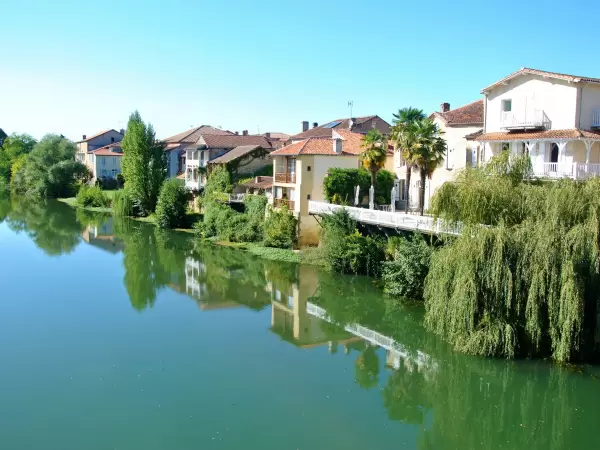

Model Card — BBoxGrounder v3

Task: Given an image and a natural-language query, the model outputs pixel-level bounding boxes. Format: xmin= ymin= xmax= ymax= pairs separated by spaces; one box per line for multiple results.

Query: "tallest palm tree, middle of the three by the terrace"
xmin=392 ymin=106 xmax=426 ymax=212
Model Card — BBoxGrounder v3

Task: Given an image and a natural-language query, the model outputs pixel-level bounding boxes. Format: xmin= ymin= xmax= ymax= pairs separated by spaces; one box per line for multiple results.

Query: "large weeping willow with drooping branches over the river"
xmin=424 ymin=151 xmax=600 ymax=362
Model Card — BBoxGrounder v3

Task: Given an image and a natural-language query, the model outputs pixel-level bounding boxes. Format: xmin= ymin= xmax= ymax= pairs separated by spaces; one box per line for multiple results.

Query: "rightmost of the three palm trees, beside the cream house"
xmin=411 ymin=119 xmax=446 ymax=215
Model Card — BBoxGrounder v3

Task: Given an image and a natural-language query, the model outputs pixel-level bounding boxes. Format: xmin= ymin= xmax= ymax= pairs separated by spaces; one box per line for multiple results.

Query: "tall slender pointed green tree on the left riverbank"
xmin=121 ymin=111 xmax=167 ymax=216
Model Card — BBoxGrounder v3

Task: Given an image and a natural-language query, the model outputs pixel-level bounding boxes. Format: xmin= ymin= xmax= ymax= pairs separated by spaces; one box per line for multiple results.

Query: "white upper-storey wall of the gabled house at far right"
xmin=486 ymin=75 xmax=577 ymax=133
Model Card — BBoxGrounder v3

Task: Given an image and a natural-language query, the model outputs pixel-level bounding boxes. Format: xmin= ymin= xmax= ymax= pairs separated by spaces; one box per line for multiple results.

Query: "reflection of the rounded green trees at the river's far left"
xmin=2 ymin=197 xmax=84 ymax=256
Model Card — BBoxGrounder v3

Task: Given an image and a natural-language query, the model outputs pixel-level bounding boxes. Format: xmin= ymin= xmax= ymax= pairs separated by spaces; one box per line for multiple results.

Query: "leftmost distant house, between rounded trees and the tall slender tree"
xmin=75 ymin=130 xmax=125 ymax=180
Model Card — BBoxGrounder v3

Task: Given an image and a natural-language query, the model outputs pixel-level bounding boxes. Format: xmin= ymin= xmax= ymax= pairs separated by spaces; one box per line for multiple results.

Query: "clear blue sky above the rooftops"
xmin=0 ymin=0 xmax=600 ymax=140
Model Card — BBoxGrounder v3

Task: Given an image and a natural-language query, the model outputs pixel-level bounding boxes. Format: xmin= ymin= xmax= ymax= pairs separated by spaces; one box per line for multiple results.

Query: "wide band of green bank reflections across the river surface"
xmin=0 ymin=200 xmax=600 ymax=449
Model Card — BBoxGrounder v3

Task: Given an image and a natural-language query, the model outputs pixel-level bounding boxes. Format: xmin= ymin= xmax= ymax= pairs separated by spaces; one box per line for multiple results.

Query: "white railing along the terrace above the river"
xmin=308 ymin=200 xmax=462 ymax=235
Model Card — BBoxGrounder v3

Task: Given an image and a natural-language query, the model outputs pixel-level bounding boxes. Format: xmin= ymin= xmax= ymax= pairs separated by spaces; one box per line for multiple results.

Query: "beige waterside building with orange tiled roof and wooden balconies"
xmin=271 ymin=129 xmax=393 ymax=246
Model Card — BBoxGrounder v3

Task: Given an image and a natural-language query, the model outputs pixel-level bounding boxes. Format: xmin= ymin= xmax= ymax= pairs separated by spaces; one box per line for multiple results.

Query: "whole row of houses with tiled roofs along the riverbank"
xmin=77 ymin=68 xmax=600 ymax=245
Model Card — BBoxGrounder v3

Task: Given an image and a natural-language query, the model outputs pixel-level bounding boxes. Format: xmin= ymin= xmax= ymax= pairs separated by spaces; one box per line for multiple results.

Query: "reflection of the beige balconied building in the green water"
xmin=267 ymin=266 xmax=358 ymax=353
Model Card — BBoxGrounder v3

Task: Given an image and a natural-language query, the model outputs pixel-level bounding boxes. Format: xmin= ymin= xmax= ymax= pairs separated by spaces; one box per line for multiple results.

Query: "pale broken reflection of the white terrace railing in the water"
xmin=306 ymin=302 xmax=438 ymax=371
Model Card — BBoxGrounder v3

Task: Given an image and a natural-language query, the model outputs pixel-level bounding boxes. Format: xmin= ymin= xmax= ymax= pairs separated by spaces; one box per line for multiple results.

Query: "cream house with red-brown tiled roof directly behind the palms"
xmin=394 ymin=100 xmax=484 ymax=210
